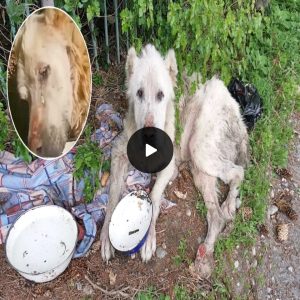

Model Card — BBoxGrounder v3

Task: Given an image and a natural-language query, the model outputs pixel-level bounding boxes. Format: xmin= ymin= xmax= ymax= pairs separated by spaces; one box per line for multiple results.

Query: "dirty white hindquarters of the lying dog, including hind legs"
xmin=179 ymin=77 xmax=248 ymax=277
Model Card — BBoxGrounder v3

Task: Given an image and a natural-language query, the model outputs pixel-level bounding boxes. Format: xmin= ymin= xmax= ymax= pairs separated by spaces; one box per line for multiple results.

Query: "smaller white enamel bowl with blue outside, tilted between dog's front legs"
xmin=109 ymin=191 xmax=152 ymax=254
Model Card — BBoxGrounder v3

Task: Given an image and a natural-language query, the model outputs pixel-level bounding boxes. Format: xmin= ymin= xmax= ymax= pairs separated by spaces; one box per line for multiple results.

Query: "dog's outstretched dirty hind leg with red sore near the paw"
xmin=192 ymin=167 xmax=225 ymax=278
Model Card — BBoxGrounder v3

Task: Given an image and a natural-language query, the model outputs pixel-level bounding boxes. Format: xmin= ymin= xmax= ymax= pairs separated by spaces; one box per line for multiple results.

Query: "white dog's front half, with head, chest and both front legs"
xmin=100 ymin=45 xmax=177 ymax=262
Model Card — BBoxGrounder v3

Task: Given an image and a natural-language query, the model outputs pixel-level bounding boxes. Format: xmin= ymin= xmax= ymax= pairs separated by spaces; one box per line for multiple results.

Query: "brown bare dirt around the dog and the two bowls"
xmin=0 ymin=66 xmax=206 ymax=300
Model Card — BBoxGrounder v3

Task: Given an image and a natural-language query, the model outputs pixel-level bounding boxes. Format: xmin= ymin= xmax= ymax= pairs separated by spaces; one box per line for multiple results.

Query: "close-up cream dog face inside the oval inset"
xmin=18 ymin=22 xmax=73 ymax=156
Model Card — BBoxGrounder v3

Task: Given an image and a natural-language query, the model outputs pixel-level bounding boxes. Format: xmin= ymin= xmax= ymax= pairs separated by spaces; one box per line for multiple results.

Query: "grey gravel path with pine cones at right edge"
xmin=220 ymin=113 xmax=300 ymax=300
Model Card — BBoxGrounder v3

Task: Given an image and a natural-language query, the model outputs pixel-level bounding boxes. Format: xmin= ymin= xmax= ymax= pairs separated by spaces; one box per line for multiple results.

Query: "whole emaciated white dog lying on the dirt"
xmin=101 ymin=45 xmax=248 ymax=277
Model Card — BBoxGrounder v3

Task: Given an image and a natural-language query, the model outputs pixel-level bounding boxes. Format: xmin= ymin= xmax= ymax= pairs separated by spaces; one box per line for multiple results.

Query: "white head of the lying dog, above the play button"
xmin=126 ymin=45 xmax=178 ymax=130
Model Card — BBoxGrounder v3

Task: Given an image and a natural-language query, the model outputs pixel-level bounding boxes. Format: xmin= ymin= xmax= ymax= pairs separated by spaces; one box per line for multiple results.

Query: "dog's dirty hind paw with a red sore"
xmin=189 ymin=244 xmax=214 ymax=279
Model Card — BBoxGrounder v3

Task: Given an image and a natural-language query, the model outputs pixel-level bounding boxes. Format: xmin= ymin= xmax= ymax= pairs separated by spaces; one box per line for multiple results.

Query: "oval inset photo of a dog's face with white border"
xmin=7 ymin=7 xmax=91 ymax=159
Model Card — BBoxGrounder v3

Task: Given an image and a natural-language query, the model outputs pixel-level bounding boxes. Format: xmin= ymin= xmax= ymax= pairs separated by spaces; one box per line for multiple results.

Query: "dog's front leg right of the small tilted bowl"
xmin=141 ymin=156 xmax=175 ymax=262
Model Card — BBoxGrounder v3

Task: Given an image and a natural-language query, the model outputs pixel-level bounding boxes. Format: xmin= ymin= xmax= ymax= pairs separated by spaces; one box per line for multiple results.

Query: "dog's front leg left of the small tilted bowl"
xmin=100 ymin=136 xmax=128 ymax=262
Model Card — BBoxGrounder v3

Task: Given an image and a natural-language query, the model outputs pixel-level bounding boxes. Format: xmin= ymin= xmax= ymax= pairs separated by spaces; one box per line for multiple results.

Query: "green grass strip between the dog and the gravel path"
xmin=135 ymin=0 xmax=300 ymax=299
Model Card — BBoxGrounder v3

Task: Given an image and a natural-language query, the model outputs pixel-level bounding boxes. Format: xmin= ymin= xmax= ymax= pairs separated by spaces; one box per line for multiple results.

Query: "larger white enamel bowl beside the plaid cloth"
xmin=5 ymin=205 xmax=78 ymax=282
